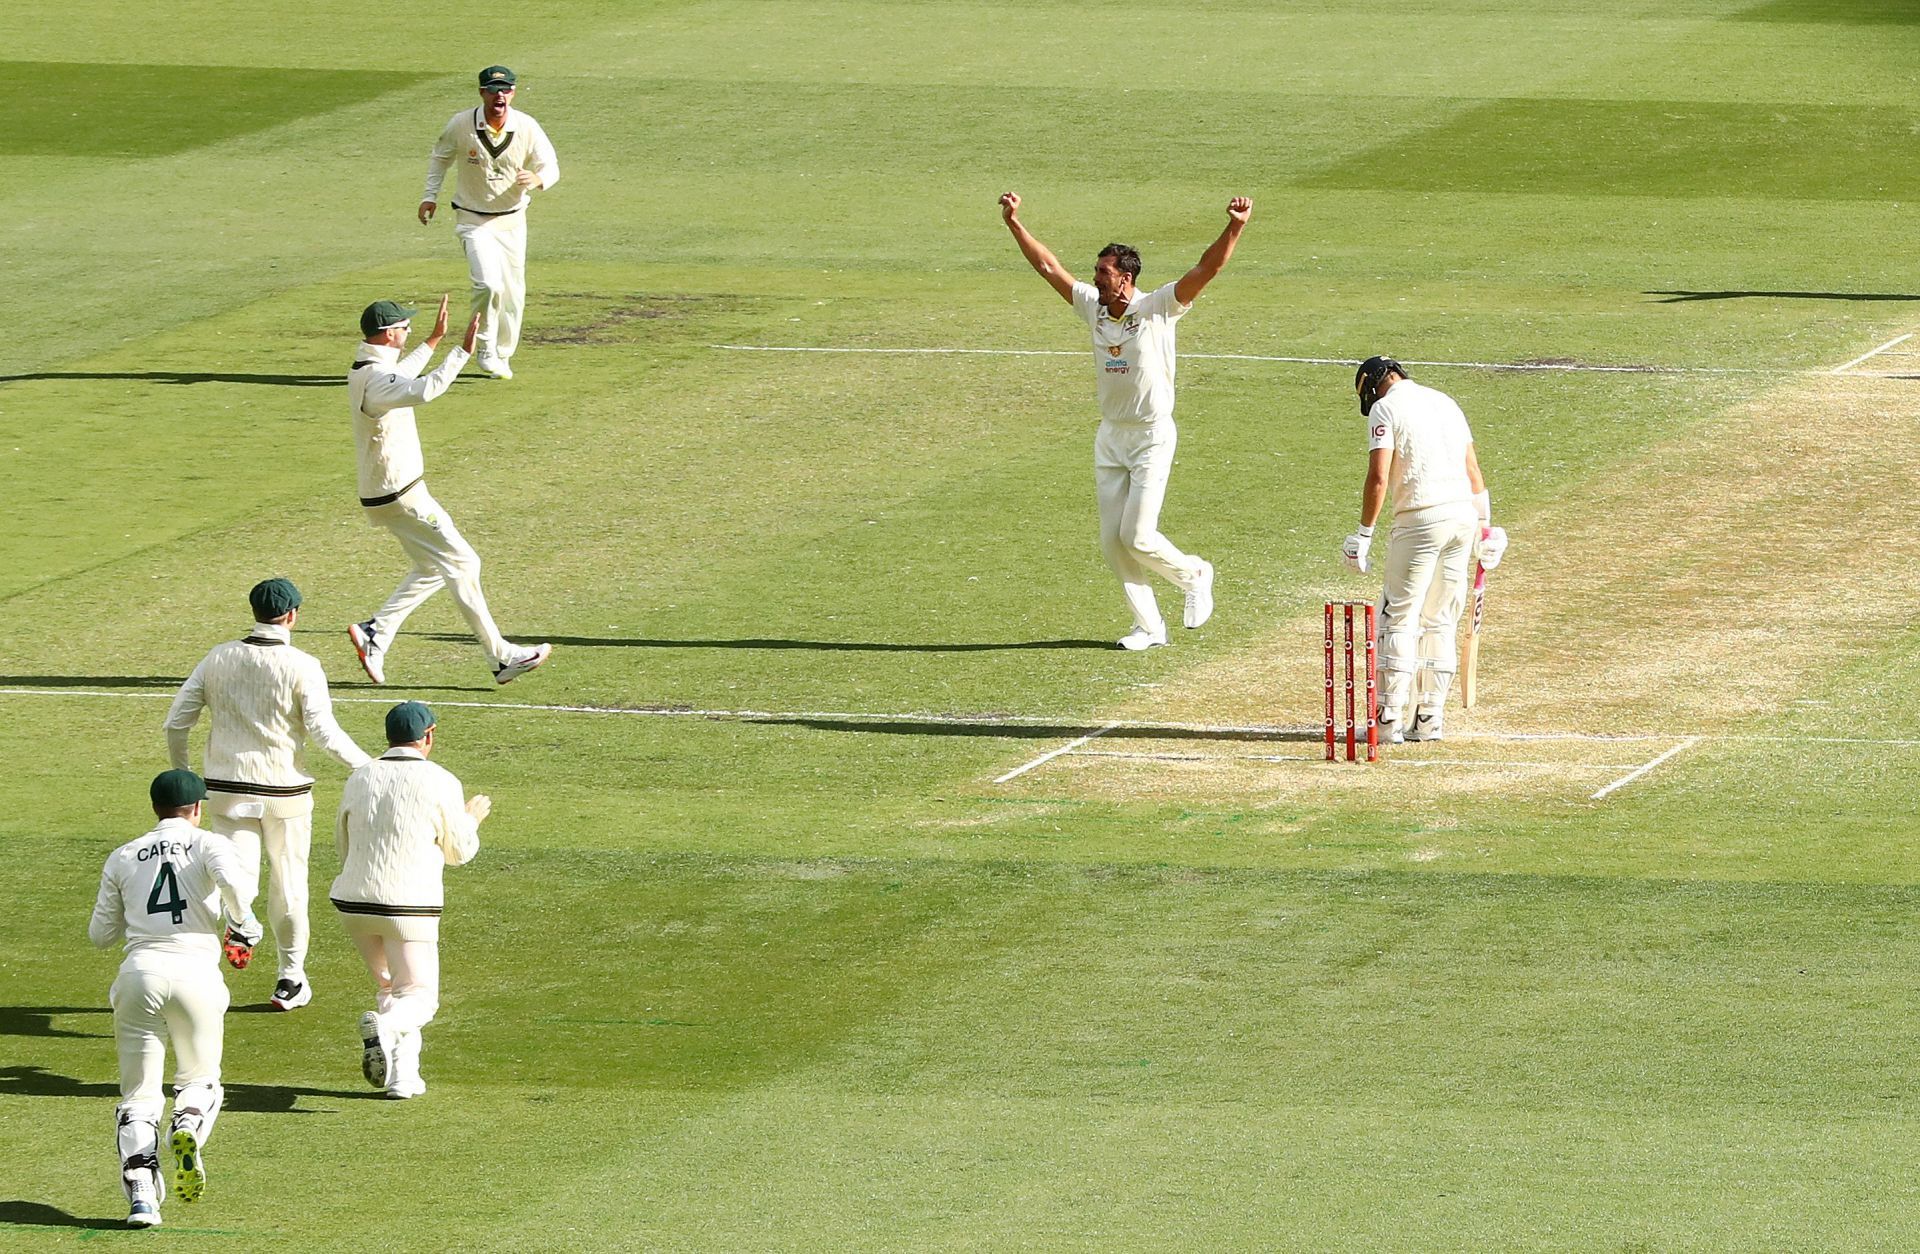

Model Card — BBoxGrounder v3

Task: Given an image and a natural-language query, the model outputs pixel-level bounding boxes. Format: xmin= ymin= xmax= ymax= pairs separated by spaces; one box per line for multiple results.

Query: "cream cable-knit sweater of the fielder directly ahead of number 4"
xmin=163 ymin=622 xmax=367 ymax=797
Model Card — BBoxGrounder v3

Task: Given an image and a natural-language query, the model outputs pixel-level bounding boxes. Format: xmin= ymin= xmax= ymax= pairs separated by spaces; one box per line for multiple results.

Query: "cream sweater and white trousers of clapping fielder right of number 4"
xmin=332 ymin=747 xmax=480 ymax=1097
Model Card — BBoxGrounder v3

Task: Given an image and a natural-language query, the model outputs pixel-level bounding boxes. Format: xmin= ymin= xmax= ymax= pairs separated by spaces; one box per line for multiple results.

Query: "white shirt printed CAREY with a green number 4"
xmin=86 ymin=818 xmax=259 ymax=966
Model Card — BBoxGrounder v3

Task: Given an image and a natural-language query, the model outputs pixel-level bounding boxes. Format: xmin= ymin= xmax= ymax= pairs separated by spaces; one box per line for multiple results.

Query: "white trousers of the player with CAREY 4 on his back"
xmin=108 ymin=947 xmax=228 ymax=1121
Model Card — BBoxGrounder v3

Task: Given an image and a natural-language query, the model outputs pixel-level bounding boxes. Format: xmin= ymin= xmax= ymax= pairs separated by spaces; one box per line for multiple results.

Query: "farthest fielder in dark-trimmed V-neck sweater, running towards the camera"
xmin=419 ymin=65 xmax=561 ymax=378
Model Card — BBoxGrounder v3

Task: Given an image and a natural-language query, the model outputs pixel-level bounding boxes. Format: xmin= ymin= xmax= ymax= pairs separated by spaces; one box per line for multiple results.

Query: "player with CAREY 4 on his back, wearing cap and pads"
xmin=86 ymin=770 xmax=259 ymax=1227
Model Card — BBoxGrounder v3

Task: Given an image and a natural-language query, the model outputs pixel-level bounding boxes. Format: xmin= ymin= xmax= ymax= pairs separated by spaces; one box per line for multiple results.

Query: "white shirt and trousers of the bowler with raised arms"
xmin=1073 ymin=282 xmax=1208 ymax=643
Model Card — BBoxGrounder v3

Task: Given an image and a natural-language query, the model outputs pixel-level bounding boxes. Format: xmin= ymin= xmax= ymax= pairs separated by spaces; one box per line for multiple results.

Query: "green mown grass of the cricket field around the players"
xmin=0 ymin=0 xmax=1920 ymax=1250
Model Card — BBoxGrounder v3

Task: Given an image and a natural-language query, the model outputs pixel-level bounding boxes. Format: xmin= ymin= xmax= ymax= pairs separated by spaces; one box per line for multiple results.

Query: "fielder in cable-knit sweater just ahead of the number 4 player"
xmin=165 ymin=580 xmax=367 ymax=1010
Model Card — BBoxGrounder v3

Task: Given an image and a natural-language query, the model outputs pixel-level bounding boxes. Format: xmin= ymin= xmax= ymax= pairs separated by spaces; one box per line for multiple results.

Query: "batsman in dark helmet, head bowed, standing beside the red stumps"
xmin=1342 ymin=357 xmax=1507 ymax=745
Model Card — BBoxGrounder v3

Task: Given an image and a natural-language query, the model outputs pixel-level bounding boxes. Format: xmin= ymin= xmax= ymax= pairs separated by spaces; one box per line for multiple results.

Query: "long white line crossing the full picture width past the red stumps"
xmin=0 ymin=684 xmax=1920 ymax=749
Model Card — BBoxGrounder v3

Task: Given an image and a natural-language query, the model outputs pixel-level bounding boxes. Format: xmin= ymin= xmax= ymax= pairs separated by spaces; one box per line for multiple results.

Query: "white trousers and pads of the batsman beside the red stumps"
xmin=1379 ymin=501 xmax=1480 ymax=722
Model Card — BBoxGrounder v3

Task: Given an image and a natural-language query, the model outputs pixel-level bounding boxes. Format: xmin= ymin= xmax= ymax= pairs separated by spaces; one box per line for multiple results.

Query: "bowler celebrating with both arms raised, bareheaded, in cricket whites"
xmin=1000 ymin=192 xmax=1254 ymax=649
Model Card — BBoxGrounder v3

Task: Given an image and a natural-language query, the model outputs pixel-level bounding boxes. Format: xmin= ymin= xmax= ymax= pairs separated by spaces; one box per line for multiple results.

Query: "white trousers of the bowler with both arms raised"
xmin=1092 ymin=419 xmax=1202 ymax=632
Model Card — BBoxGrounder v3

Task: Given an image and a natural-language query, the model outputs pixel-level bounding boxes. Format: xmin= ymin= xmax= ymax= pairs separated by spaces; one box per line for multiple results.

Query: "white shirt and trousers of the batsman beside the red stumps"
xmin=1367 ymin=378 xmax=1480 ymax=722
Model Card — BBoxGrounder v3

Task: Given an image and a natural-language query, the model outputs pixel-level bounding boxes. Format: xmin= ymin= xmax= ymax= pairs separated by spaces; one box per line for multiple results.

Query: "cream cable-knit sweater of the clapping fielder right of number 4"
xmin=328 ymin=749 xmax=480 ymax=916
